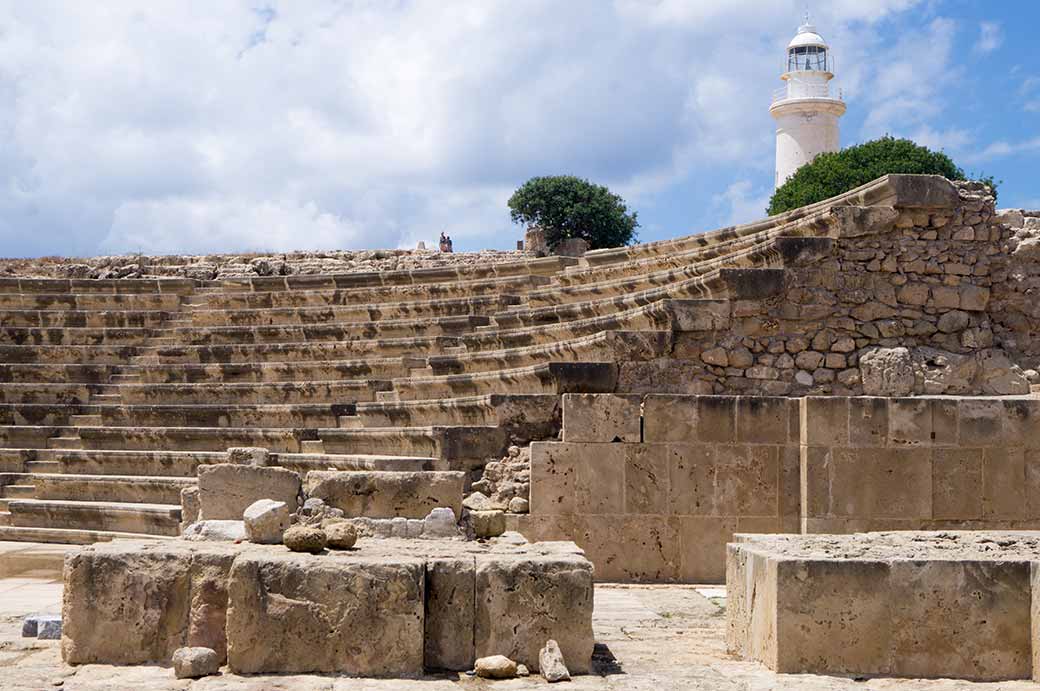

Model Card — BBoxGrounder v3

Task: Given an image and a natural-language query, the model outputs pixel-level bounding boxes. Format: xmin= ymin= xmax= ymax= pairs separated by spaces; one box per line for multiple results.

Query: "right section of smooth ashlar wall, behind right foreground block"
xmin=801 ymin=396 xmax=1040 ymax=533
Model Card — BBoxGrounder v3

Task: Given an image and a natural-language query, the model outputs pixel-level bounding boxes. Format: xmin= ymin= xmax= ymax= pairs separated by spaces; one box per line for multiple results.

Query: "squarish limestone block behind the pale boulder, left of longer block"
xmin=199 ymin=463 xmax=301 ymax=520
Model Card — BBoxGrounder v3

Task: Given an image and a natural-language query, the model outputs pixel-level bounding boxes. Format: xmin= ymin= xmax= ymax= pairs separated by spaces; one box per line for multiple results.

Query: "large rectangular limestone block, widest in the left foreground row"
xmin=228 ymin=553 xmax=424 ymax=677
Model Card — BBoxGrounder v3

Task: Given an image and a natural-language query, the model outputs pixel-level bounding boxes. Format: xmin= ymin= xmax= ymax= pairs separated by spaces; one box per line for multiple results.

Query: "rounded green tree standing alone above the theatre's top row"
xmin=509 ymin=175 xmax=640 ymax=250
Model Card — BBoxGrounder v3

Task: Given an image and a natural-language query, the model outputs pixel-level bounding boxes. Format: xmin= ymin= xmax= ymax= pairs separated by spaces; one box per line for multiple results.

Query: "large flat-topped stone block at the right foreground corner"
xmin=727 ymin=531 xmax=1040 ymax=682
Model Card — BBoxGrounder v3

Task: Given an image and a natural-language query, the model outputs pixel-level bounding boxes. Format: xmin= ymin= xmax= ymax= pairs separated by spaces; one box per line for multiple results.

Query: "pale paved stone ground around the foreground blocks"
xmin=0 ymin=543 xmax=1040 ymax=691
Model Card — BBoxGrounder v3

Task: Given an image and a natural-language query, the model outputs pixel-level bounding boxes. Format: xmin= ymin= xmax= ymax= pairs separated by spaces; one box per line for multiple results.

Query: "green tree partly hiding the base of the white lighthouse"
xmin=766 ymin=136 xmax=996 ymax=215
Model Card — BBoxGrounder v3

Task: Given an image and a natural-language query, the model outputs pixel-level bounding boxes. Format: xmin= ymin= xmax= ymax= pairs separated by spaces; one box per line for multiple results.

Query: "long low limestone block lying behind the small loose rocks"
xmin=306 ymin=470 xmax=465 ymax=518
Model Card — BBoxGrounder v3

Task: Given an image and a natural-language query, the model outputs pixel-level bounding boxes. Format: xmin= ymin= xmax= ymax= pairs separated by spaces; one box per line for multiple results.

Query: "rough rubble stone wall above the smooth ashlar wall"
xmin=676 ymin=183 xmax=1040 ymax=395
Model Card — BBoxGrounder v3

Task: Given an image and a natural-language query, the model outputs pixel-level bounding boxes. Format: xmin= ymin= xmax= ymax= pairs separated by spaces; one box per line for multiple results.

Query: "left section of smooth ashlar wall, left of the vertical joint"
xmin=520 ymin=394 xmax=800 ymax=583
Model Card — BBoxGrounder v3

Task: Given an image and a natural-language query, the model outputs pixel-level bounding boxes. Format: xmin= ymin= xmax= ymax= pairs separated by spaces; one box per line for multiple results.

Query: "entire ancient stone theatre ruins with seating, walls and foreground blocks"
xmin=0 ymin=175 xmax=1040 ymax=689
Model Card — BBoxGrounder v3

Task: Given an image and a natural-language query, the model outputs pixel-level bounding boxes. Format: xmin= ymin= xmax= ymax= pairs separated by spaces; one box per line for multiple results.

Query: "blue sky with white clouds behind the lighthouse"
xmin=0 ymin=0 xmax=1040 ymax=257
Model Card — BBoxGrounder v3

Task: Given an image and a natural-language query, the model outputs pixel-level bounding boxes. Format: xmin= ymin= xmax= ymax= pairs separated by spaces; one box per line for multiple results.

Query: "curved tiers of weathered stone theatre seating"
xmin=0 ymin=177 xmax=919 ymax=542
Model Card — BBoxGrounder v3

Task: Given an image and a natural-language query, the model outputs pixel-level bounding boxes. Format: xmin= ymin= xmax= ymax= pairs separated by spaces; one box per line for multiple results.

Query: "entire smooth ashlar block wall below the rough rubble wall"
xmin=528 ymin=394 xmax=1040 ymax=583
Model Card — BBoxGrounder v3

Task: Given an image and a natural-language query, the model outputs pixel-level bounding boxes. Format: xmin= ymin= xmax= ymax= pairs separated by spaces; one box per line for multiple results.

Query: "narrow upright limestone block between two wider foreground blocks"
xmin=424 ymin=556 xmax=476 ymax=671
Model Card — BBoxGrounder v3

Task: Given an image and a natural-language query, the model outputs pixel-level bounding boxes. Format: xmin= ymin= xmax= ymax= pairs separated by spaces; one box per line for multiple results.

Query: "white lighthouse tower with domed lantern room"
xmin=770 ymin=17 xmax=846 ymax=187
